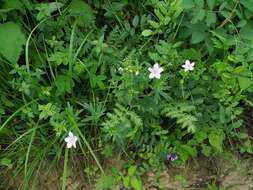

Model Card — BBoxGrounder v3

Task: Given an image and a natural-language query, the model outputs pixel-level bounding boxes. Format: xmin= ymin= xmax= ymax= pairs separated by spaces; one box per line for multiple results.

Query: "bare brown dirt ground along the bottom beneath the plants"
xmin=0 ymin=154 xmax=253 ymax=190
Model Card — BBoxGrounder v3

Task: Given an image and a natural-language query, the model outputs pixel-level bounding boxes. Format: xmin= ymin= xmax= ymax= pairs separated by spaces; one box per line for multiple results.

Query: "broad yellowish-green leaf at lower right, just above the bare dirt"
xmin=208 ymin=129 xmax=225 ymax=152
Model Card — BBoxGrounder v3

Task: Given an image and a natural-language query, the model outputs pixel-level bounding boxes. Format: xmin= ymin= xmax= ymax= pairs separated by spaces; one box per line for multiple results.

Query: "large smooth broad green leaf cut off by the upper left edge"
xmin=0 ymin=22 xmax=26 ymax=63
